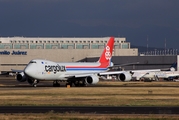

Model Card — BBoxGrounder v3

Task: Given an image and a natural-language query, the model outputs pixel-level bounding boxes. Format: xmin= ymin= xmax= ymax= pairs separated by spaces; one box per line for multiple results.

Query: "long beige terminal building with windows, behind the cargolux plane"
xmin=0 ymin=37 xmax=138 ymax=71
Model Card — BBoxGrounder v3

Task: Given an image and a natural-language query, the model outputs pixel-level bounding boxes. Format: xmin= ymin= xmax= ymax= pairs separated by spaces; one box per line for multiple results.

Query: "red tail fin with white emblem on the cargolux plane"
xmin=99 ymin=37 xmax=114 ymax=63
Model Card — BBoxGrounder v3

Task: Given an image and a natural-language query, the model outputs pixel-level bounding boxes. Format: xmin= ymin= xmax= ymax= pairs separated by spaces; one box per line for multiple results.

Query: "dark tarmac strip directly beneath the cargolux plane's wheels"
xmin=0 ymin=76 xmax=179 ymax=88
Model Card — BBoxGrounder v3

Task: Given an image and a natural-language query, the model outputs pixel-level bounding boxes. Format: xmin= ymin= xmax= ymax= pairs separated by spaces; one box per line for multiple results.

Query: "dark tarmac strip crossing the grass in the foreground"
xmin=0 ymin=106 xmax=179 ymax=114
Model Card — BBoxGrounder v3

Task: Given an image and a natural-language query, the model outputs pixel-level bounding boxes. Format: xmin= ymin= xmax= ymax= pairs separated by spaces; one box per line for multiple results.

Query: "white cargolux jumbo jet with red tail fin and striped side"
xmin=12 ymin=37 xmax=114 ymax=87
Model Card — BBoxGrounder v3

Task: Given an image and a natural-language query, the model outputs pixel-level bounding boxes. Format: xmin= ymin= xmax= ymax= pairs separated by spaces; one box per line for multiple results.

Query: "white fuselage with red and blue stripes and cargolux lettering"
xmin=24 ymin=59 xmax=107 ymax=80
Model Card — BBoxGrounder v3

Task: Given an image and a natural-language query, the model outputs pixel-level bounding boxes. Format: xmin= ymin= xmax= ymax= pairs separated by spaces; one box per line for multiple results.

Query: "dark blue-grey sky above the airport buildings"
xmin=0 ymin=0 xmax=179 ymax=49
